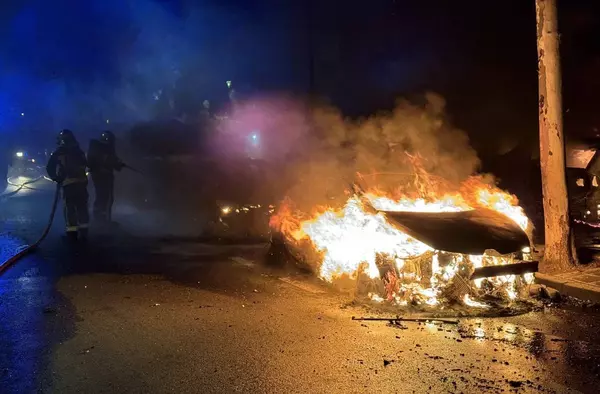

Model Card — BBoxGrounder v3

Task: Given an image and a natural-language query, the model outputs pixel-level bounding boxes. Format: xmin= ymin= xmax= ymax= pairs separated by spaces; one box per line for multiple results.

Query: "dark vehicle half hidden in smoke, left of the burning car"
xmin=118 ymin=121 xmax=280 ymax=239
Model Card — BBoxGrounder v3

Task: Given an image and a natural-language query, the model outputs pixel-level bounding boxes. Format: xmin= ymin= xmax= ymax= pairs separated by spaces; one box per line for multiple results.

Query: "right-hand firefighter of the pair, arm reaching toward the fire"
xmin=88 ymin=131 xmax=125 ymax=224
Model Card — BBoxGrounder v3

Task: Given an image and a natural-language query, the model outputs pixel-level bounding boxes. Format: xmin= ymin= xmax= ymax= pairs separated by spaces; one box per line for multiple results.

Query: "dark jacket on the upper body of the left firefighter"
xmin=46 ymin=144 xmax=87 ymax=186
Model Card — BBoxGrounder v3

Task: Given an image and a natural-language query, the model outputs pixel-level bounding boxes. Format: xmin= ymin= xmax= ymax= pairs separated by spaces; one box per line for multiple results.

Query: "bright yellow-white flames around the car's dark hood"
xmin=271 ymin=178 xmax=532 ymax=308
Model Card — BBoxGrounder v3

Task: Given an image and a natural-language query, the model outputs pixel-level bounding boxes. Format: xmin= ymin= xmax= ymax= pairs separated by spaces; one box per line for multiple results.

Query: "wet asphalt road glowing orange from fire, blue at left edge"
xmin=0 ymin=185 xmax=600 ymax=394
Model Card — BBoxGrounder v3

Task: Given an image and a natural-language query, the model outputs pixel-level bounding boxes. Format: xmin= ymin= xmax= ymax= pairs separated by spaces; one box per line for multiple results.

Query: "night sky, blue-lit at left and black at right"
xmin=0 ymin=0 xmax=600 ymax=155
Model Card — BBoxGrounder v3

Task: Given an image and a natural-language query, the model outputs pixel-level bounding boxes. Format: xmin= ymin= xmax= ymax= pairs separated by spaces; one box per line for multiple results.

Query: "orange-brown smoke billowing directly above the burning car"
xmin=284 ymin=93 xmax=480 ymax=212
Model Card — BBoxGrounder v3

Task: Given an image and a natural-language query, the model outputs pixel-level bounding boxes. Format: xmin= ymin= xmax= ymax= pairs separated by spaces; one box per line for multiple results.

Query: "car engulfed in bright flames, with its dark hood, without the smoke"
xmin=271 ymin=177 xmax=536 ymax=308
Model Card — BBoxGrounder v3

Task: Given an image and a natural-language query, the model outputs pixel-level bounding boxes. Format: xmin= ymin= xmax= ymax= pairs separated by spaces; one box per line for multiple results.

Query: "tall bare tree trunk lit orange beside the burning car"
xmin=536 ymin=0 xmax=575 ymax=272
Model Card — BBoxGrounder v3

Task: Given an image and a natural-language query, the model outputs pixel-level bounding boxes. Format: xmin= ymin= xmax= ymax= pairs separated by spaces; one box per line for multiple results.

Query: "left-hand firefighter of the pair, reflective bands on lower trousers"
xmin=46 ymin=129 xmax=90 ymax=241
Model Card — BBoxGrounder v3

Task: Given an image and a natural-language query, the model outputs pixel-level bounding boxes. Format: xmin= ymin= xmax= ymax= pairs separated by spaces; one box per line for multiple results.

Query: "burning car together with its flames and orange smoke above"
xmin=260 ymin=96 xmax=538 ymax=316
